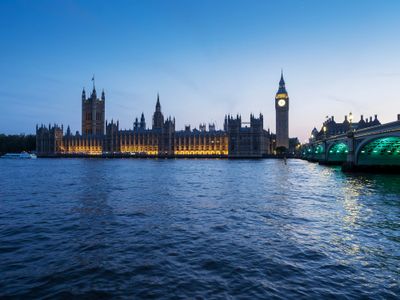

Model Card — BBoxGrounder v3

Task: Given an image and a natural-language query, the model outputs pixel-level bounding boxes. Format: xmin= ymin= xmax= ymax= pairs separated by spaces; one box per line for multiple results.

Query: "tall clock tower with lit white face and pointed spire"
xmin=275 ymin=72 xmax=289 ymax=149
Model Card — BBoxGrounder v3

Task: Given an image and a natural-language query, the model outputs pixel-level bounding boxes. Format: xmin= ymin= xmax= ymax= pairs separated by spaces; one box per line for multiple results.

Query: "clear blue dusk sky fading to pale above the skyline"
xmin=0 ymin=0 xmax=400 ymax=142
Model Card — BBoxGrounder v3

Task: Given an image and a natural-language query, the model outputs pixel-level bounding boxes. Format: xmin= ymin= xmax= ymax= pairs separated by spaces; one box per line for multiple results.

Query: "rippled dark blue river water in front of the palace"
xmin=0 ymin=159 xmax=400 ymax=299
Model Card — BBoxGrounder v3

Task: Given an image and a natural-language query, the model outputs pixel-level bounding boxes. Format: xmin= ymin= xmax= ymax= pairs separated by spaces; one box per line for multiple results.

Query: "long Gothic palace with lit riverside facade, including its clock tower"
xmin=36 ymin=74 xmax=298 ymax=158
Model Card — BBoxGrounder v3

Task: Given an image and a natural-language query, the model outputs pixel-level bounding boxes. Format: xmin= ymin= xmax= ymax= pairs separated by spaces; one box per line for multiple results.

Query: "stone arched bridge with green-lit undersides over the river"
xmin=301 ymin=117 xmax=400 ymax=173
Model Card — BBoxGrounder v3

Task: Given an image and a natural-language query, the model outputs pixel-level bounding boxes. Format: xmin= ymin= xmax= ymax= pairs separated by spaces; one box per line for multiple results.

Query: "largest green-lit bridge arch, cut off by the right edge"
xmin=355 ymin=133 xmax=400 ymax=166
